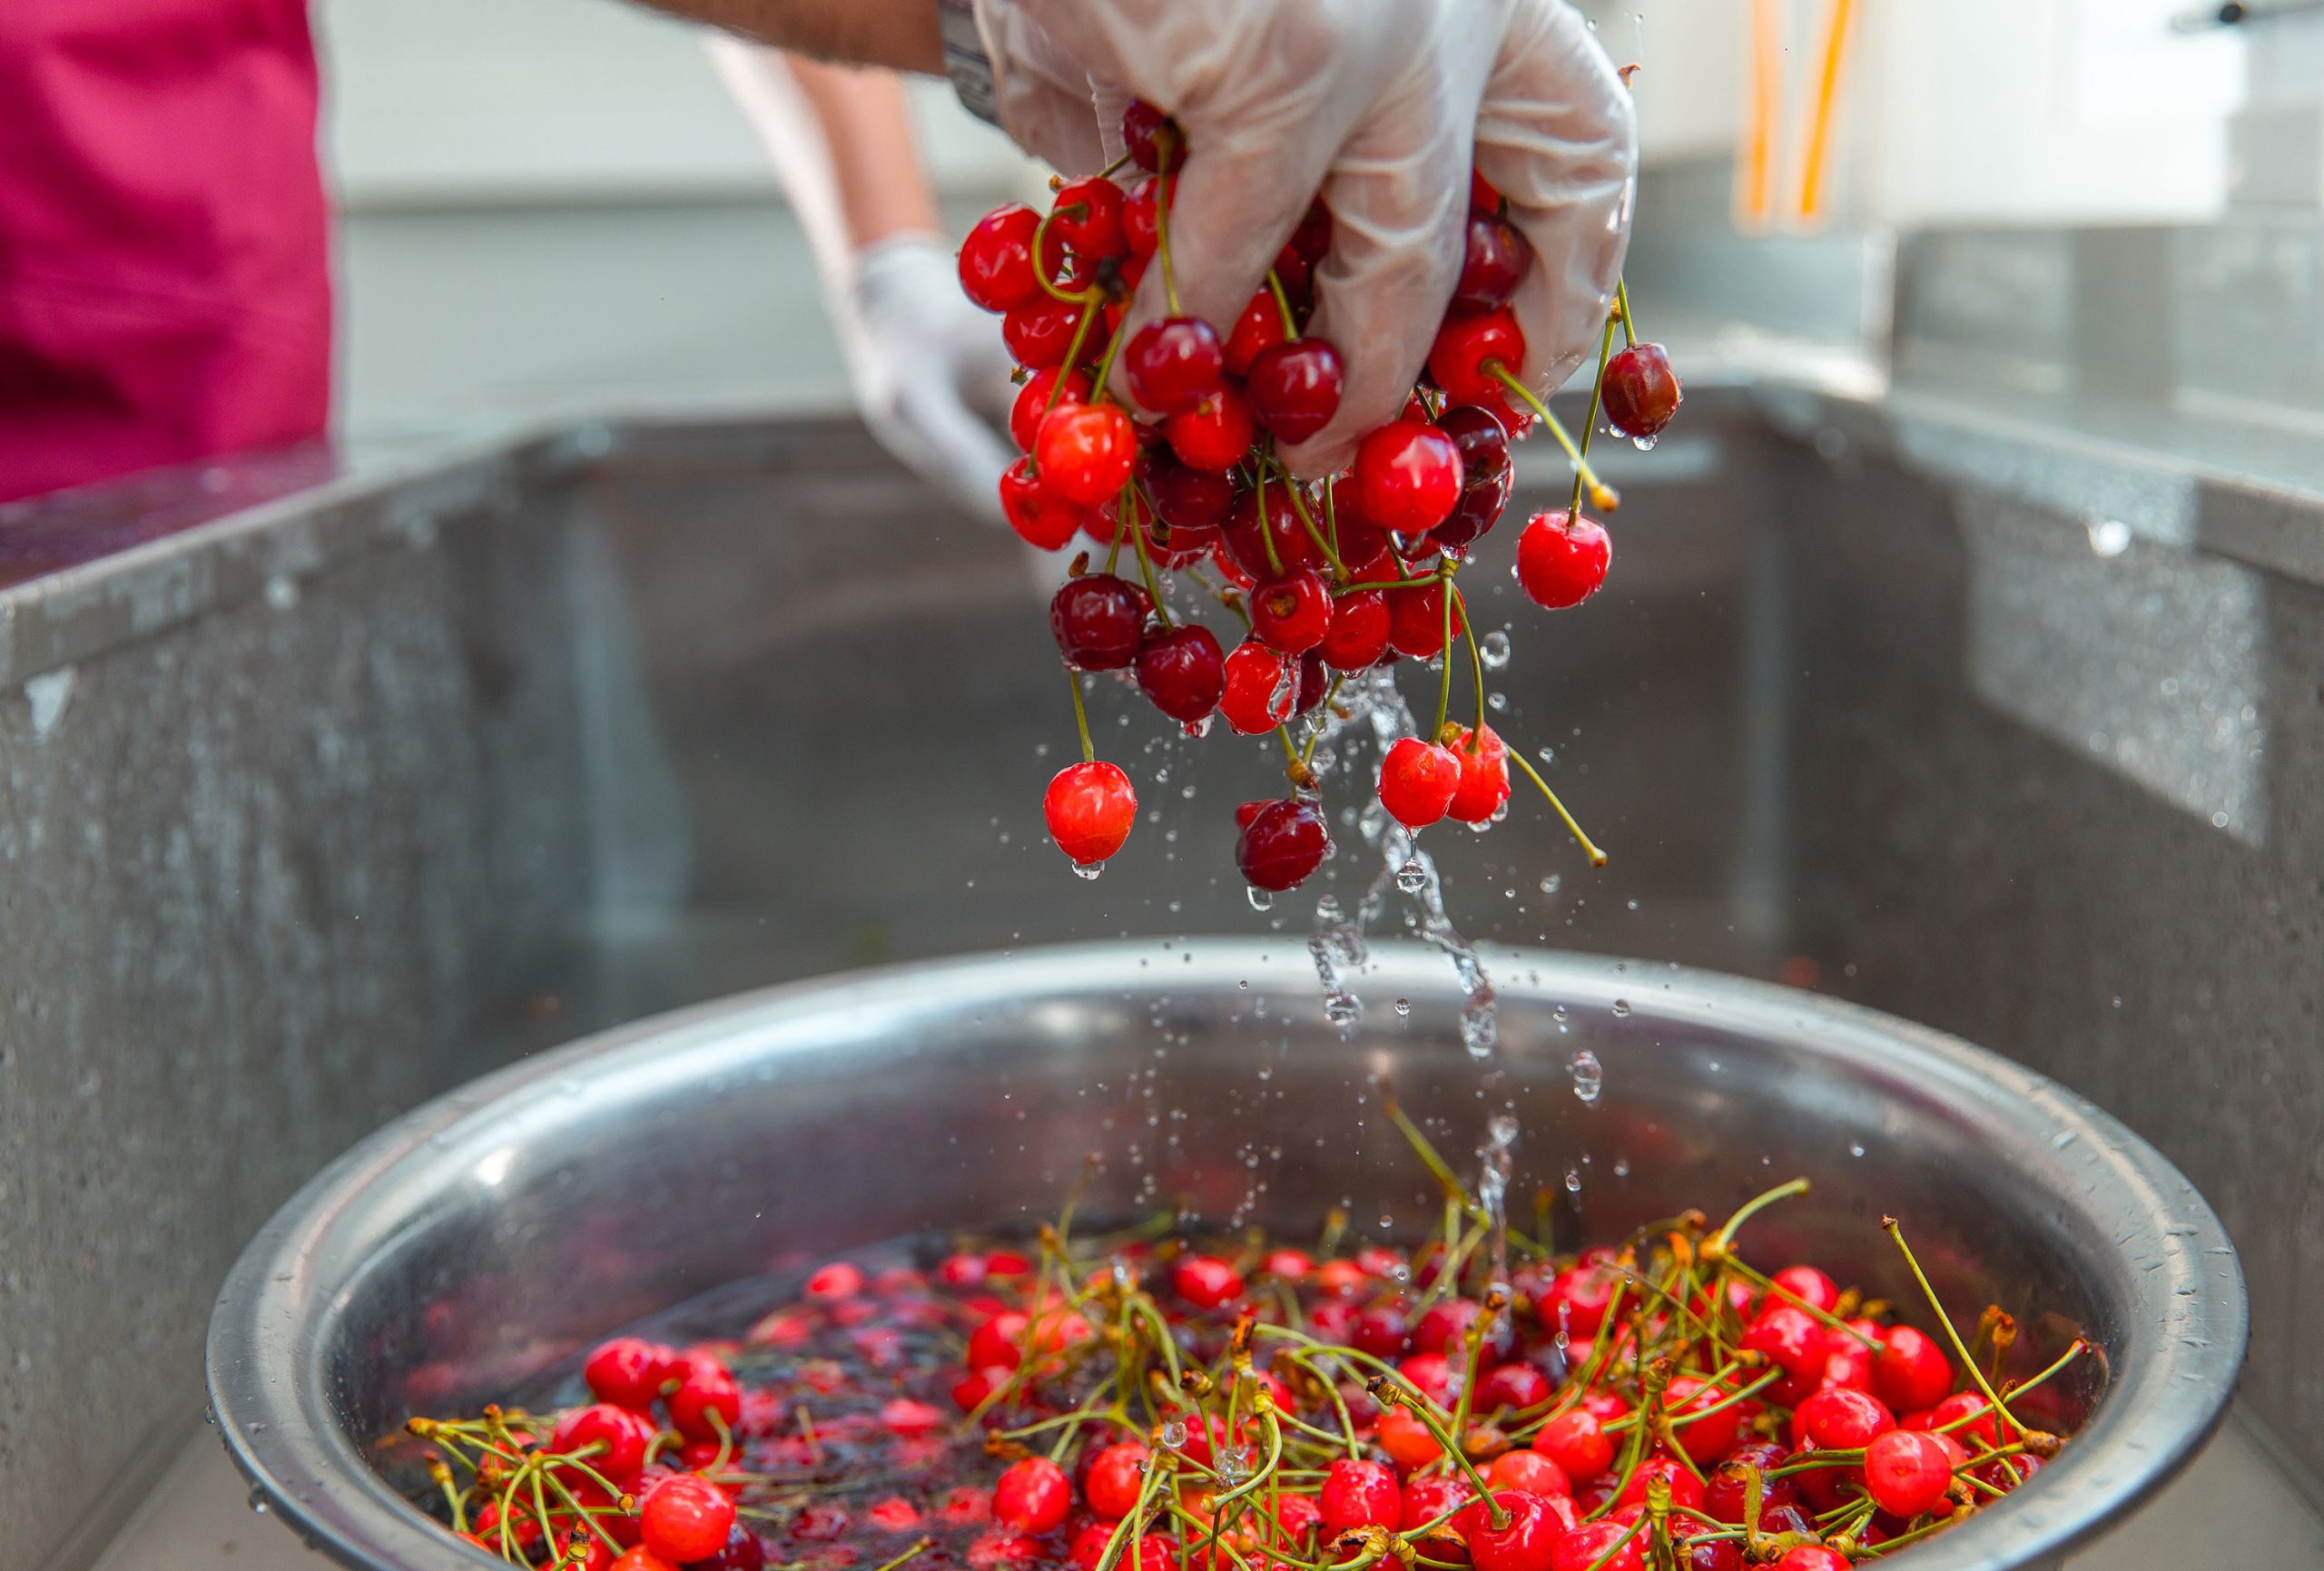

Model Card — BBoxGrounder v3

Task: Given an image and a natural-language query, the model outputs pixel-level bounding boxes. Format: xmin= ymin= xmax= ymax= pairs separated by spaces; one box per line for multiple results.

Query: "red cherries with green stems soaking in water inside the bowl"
xmin=399 ymin=1143 xmax=2084 ymax=1571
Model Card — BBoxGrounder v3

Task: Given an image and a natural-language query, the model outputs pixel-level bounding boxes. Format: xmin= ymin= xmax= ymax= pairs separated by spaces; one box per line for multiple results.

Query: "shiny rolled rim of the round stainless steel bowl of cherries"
xmin=204 ymin=937 xmax=2250 ymax=1571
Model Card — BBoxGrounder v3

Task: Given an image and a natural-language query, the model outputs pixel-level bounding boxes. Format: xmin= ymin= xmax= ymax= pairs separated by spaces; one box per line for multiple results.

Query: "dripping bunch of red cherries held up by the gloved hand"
xmin=960 ymin=103 xmax=1680 ymax=892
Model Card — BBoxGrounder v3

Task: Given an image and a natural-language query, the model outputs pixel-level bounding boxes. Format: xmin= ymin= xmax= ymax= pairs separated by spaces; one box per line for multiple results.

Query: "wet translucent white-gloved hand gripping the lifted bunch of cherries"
xmin=976 ymin=0 xmax=1636 ymax=474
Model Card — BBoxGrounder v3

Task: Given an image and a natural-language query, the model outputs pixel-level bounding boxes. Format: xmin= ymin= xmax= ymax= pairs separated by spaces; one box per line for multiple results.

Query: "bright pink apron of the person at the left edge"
xmin=0 ymin=0 xmax=330 ymax=500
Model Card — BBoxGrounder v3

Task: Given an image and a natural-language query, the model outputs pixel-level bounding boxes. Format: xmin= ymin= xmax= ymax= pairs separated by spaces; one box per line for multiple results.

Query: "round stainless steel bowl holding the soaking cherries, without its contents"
xmin=209 ymin=941 xmax=2245 ymax=1571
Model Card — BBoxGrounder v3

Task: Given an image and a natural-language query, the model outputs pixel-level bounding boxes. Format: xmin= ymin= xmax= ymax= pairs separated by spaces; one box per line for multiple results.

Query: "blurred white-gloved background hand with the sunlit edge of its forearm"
xmin=709 ymin=34 xmax=1016 ymax=523
